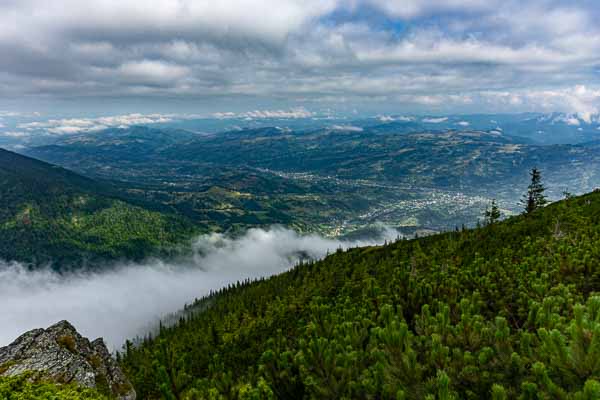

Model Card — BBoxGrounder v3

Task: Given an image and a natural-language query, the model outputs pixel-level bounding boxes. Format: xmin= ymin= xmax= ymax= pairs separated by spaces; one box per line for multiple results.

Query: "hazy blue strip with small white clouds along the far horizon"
xmin=0 ymin=108 xmax=600 ymax=147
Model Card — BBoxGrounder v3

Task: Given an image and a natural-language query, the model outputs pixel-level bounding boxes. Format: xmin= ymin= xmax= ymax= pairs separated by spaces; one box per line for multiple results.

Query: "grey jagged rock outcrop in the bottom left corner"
xmin=0 ymin=321 xmax=135 ymax=400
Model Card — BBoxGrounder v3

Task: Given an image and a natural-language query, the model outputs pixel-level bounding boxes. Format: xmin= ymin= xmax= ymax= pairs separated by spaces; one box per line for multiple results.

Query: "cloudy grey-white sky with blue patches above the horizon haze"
xmin=0 ymin=0 xmax=600 ymax=117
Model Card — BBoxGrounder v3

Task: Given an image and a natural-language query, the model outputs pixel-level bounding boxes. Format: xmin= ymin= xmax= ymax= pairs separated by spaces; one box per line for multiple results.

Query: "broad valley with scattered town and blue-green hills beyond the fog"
xmin=24 ymin=123 xmax=600 ymax=239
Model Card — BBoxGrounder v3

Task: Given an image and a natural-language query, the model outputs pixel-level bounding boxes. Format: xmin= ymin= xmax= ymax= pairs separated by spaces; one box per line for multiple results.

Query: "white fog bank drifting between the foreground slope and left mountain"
xmin=0 ymin=228 xmax=397 ymax=349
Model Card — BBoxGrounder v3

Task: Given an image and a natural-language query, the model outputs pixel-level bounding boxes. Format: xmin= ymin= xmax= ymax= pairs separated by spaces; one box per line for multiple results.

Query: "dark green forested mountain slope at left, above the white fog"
xmin=0 ymin=149 xmax=192 ymax=268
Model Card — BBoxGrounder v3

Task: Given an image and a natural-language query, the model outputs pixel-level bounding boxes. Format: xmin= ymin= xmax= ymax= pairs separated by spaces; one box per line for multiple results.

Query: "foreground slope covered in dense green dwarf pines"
xmin=121 ymin=189 xmax=600 ymax=400
